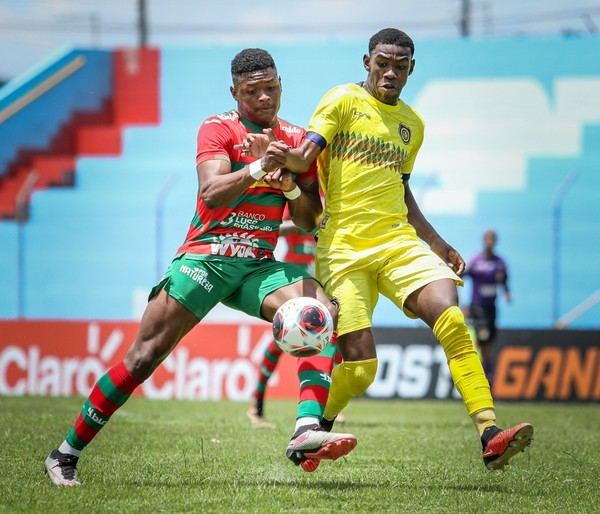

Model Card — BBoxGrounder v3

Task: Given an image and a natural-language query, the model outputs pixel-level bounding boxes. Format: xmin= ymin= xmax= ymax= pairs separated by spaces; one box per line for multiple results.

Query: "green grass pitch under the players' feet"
xmin=0 ymin=397 xmax=600 ymax=513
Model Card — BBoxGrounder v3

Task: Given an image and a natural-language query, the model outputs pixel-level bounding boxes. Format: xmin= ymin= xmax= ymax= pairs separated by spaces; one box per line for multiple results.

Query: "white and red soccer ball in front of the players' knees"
xmin=273 ymin=296 xmax=333 ymax=357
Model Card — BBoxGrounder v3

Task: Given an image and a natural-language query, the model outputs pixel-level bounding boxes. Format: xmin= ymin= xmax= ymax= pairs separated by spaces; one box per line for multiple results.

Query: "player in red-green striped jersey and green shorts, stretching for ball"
xmin=45 ymin=48 xmax=356 ymax=487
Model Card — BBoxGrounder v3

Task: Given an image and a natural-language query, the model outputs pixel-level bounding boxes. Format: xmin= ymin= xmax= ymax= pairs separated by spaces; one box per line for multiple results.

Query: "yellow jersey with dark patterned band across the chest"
xmin=307 ymin=84 xmax=425 ymax=250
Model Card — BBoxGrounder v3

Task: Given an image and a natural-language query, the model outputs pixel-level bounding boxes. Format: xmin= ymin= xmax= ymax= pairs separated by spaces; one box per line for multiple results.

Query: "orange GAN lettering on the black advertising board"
xmin=494 ymin=346 xmax=600 ymax=401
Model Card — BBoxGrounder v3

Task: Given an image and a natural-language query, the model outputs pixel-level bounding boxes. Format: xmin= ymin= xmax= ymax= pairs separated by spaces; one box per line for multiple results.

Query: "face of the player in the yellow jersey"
xmin=363 ymin=45 xmax=415 ymax=105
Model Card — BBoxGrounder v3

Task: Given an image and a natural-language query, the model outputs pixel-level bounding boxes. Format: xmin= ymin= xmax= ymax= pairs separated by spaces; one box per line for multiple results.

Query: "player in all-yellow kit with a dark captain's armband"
xmin=239 ymin=28 xmax=533 ymax=470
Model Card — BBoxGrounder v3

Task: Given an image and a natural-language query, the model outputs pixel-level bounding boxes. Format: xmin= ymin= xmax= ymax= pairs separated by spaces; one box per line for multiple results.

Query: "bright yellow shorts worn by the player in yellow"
xmin=316 ymin=231 xmax=463 ymax=335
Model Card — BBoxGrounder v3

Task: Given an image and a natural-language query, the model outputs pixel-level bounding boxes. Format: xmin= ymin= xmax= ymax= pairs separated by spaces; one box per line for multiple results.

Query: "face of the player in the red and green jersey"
xmin=231 ymin=68 xmax=281 ymax=128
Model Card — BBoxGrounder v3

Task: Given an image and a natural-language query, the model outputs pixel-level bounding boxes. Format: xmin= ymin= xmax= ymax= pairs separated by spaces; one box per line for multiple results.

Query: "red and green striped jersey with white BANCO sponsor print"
xmin=177 ymin=110 xmax=318 ymax=259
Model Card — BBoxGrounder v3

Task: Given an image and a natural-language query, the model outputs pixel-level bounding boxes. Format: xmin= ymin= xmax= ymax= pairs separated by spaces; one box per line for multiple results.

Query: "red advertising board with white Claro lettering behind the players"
xmin=0 ymin=322 xmax=297 ymax=401
